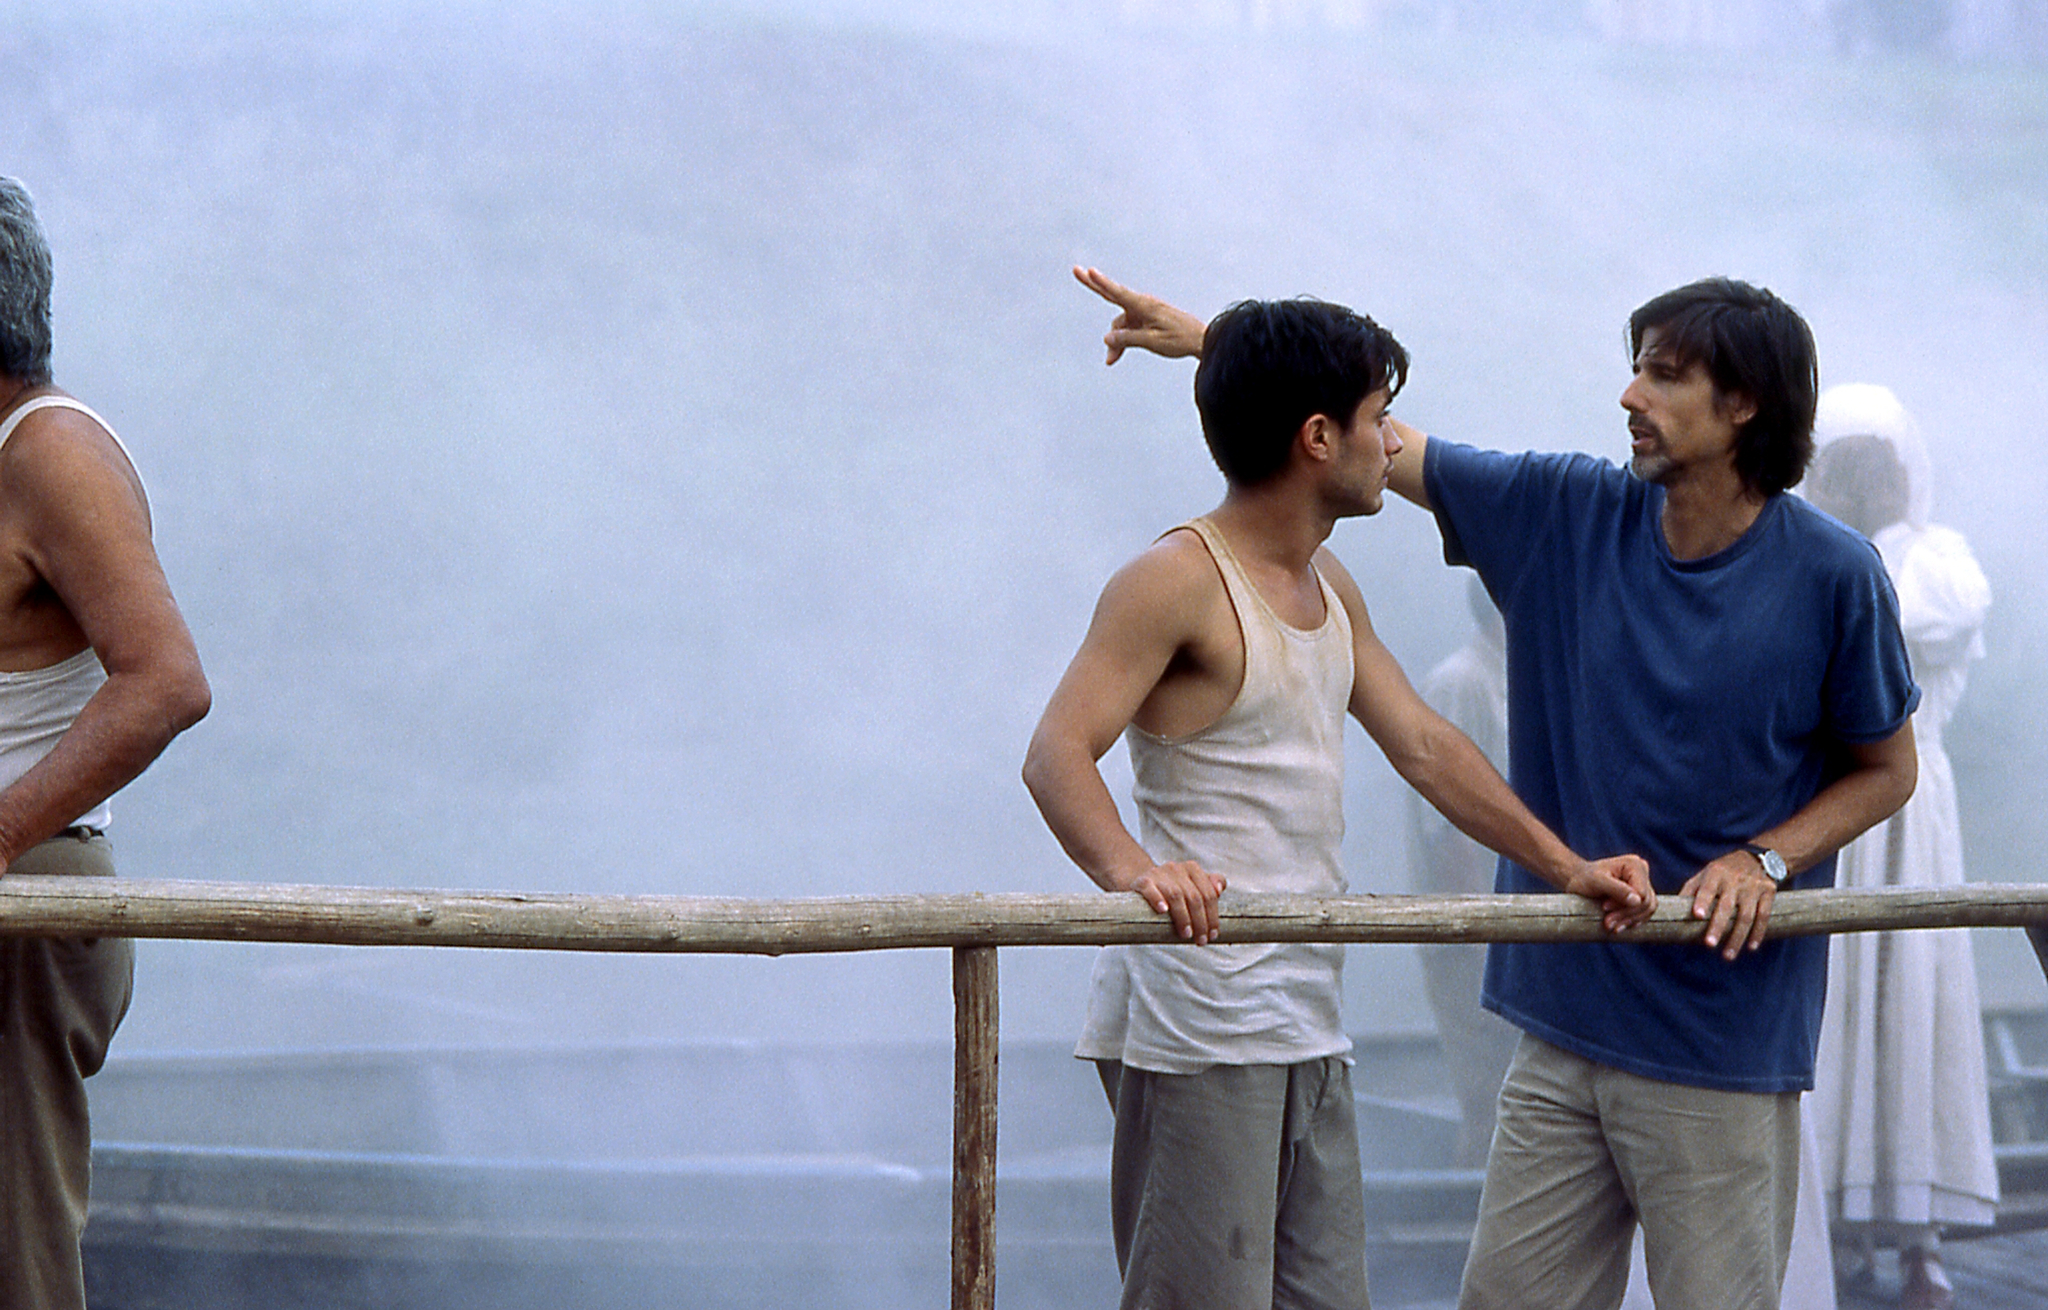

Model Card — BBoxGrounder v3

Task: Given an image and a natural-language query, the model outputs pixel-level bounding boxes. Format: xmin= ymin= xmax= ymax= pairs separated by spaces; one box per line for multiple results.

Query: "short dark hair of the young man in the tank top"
xmin=1194 ymin=297 xmax=1407 ymax=487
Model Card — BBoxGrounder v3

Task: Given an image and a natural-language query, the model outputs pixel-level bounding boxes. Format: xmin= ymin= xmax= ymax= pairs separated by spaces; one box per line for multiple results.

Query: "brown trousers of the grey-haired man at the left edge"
xmin=0 ymin=837 xmax=135 ymax=1310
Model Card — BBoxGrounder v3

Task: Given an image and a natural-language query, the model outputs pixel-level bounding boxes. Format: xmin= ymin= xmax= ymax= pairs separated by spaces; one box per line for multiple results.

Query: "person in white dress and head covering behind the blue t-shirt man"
xmin=1804 ymin=383 xmax=1999 ymax=1310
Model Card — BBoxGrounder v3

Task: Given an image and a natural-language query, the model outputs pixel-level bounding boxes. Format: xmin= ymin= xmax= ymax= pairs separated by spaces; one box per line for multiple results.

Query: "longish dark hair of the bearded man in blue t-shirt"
xmin=1628 ymin=278 xmax=1821 ymax=495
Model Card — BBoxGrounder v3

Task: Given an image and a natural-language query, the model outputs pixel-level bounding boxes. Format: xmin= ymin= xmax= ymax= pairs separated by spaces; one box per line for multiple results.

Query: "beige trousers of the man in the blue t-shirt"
xmin=1458 ymin=1036 xmax=1800 ymax=1310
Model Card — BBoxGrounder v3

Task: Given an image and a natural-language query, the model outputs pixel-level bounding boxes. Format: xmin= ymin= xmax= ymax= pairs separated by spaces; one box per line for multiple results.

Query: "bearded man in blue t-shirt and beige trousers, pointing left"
xmin=1090 ymin=278 xmax=1919 ymax=1310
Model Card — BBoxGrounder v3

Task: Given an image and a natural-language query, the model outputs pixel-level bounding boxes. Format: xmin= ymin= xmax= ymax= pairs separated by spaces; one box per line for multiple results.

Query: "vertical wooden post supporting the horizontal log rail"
xmin=952 ymin=946 xmax=999 ymax=1310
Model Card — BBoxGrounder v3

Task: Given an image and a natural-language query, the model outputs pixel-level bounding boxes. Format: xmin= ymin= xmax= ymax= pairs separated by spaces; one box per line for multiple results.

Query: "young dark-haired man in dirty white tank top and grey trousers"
xmin=1024 ymin=286 xmax=1655 ymax=1310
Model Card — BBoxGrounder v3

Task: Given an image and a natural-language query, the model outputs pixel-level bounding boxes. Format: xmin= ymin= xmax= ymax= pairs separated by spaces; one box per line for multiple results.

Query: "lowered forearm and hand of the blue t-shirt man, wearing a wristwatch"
xmin=1679 ymin=721 xmax=1919 ymax=960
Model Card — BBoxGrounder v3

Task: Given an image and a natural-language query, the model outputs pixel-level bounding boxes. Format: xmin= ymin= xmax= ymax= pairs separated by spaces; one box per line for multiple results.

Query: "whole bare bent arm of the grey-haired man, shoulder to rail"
xmin=0 ymin=411 xmax=211 ymax=868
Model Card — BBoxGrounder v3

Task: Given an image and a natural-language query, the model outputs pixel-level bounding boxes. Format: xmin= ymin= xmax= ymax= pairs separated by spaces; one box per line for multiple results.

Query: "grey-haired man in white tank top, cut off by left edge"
xmin=0 ymin=178 xmax=211 ymax=1310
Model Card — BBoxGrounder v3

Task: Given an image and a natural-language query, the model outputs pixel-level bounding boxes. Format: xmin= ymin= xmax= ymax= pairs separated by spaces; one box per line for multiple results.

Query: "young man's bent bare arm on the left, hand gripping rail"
xmin=1024 ymin=544 xmax=1225 ymax=944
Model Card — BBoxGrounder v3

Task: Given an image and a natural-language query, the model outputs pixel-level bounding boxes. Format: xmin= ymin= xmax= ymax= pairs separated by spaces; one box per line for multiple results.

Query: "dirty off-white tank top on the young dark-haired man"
xmin=1075 ymin=518 xmax=1352 ymax=1073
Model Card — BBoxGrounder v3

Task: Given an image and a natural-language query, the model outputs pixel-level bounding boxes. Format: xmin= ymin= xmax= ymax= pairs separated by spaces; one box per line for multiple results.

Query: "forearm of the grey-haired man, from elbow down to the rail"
xmin=0 ymin=665 xmax=211 ymax=870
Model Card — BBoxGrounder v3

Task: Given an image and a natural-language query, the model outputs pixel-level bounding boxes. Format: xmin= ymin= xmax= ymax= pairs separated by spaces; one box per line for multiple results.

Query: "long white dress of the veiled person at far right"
xmin=1808 ymin=524 xmax=1999 ymax=1226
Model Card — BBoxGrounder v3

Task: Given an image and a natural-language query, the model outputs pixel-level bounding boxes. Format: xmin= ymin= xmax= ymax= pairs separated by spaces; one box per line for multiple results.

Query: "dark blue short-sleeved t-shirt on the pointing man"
xmin=1423 ymin=440 xmax=1919 ymax=1091
